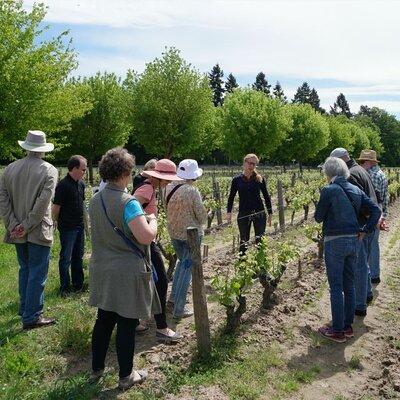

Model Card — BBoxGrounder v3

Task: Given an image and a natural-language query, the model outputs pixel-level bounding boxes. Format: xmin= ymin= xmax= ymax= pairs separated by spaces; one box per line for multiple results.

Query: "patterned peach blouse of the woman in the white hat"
xmin=166 ymin=182 xmax=207 ymax=240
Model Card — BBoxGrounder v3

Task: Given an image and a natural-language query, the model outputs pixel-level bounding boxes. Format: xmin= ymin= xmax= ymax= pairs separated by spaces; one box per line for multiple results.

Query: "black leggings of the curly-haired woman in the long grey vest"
xmin=92 ymin=308 xmax=139 ymax=378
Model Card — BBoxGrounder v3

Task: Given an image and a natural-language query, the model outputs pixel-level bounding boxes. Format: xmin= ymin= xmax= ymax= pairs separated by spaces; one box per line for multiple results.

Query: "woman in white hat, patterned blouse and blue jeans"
xmin=166 ymin=159 xmax=207 ymax=318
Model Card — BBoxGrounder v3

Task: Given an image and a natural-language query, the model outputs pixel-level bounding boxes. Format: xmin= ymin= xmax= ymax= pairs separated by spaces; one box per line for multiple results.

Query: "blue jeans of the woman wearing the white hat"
xmin=172 ymin=237 xmax=201 ymax=316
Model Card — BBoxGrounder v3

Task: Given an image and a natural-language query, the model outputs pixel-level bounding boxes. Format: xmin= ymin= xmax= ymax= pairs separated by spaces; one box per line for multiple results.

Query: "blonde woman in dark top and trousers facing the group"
xmin=226 ymin=154 xmax=272 ymax=254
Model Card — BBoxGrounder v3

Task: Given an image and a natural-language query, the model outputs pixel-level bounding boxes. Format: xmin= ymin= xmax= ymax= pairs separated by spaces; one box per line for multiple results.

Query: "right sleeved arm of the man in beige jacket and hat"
xmin=21 ymin=168 xmax=58 ymax=233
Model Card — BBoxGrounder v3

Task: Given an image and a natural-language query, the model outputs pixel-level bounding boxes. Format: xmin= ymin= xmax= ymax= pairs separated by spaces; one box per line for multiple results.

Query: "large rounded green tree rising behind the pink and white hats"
xmin=130 ymin=47 xmax=215 ymax=158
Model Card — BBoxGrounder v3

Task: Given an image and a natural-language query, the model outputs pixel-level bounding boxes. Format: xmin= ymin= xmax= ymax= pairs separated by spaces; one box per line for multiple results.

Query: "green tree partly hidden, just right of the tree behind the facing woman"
xmin=275 ymin=104 xmax=329 ymax=167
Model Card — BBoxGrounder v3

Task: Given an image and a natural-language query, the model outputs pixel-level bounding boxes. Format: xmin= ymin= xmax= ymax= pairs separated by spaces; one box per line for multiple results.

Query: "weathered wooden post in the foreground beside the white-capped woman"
xmin=187 ymin=227 xmax=211 ymax=355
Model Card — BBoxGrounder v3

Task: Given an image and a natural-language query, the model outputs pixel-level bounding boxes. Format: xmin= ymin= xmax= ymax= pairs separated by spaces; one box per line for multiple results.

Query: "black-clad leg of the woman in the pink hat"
xmin=150 ymin=242 xmax=168 ymax=329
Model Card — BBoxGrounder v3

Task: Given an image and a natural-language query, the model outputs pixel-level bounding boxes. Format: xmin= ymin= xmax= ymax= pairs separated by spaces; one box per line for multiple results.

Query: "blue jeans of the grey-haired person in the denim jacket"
xmin=324 ymin=237 xmax=360 ymax=332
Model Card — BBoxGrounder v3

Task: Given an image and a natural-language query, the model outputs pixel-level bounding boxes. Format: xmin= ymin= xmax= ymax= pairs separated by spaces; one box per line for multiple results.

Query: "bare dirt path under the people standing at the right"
xmin=280 ymin=198 xmax=400 ymax=400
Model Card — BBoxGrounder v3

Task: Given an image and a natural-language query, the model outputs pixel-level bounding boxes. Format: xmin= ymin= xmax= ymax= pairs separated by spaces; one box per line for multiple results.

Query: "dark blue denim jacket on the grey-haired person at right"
xmin=314 ymin=176 xmax=381 ymax=236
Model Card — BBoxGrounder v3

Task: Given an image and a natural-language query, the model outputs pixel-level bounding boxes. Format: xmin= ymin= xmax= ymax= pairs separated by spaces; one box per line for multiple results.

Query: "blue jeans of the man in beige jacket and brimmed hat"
xmin=15 ymin=242 xmax=50 ymax=324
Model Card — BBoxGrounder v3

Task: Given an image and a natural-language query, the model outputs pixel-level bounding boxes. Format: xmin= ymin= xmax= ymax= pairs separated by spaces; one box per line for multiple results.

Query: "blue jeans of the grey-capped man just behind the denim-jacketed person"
xmin=355 ymin=232 xmax=374 ymax=311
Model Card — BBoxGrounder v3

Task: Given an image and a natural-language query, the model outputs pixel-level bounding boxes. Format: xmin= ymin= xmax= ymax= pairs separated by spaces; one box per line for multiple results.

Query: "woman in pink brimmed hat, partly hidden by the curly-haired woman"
xmin=134 ymin=159 xmax=181 ymax=343
